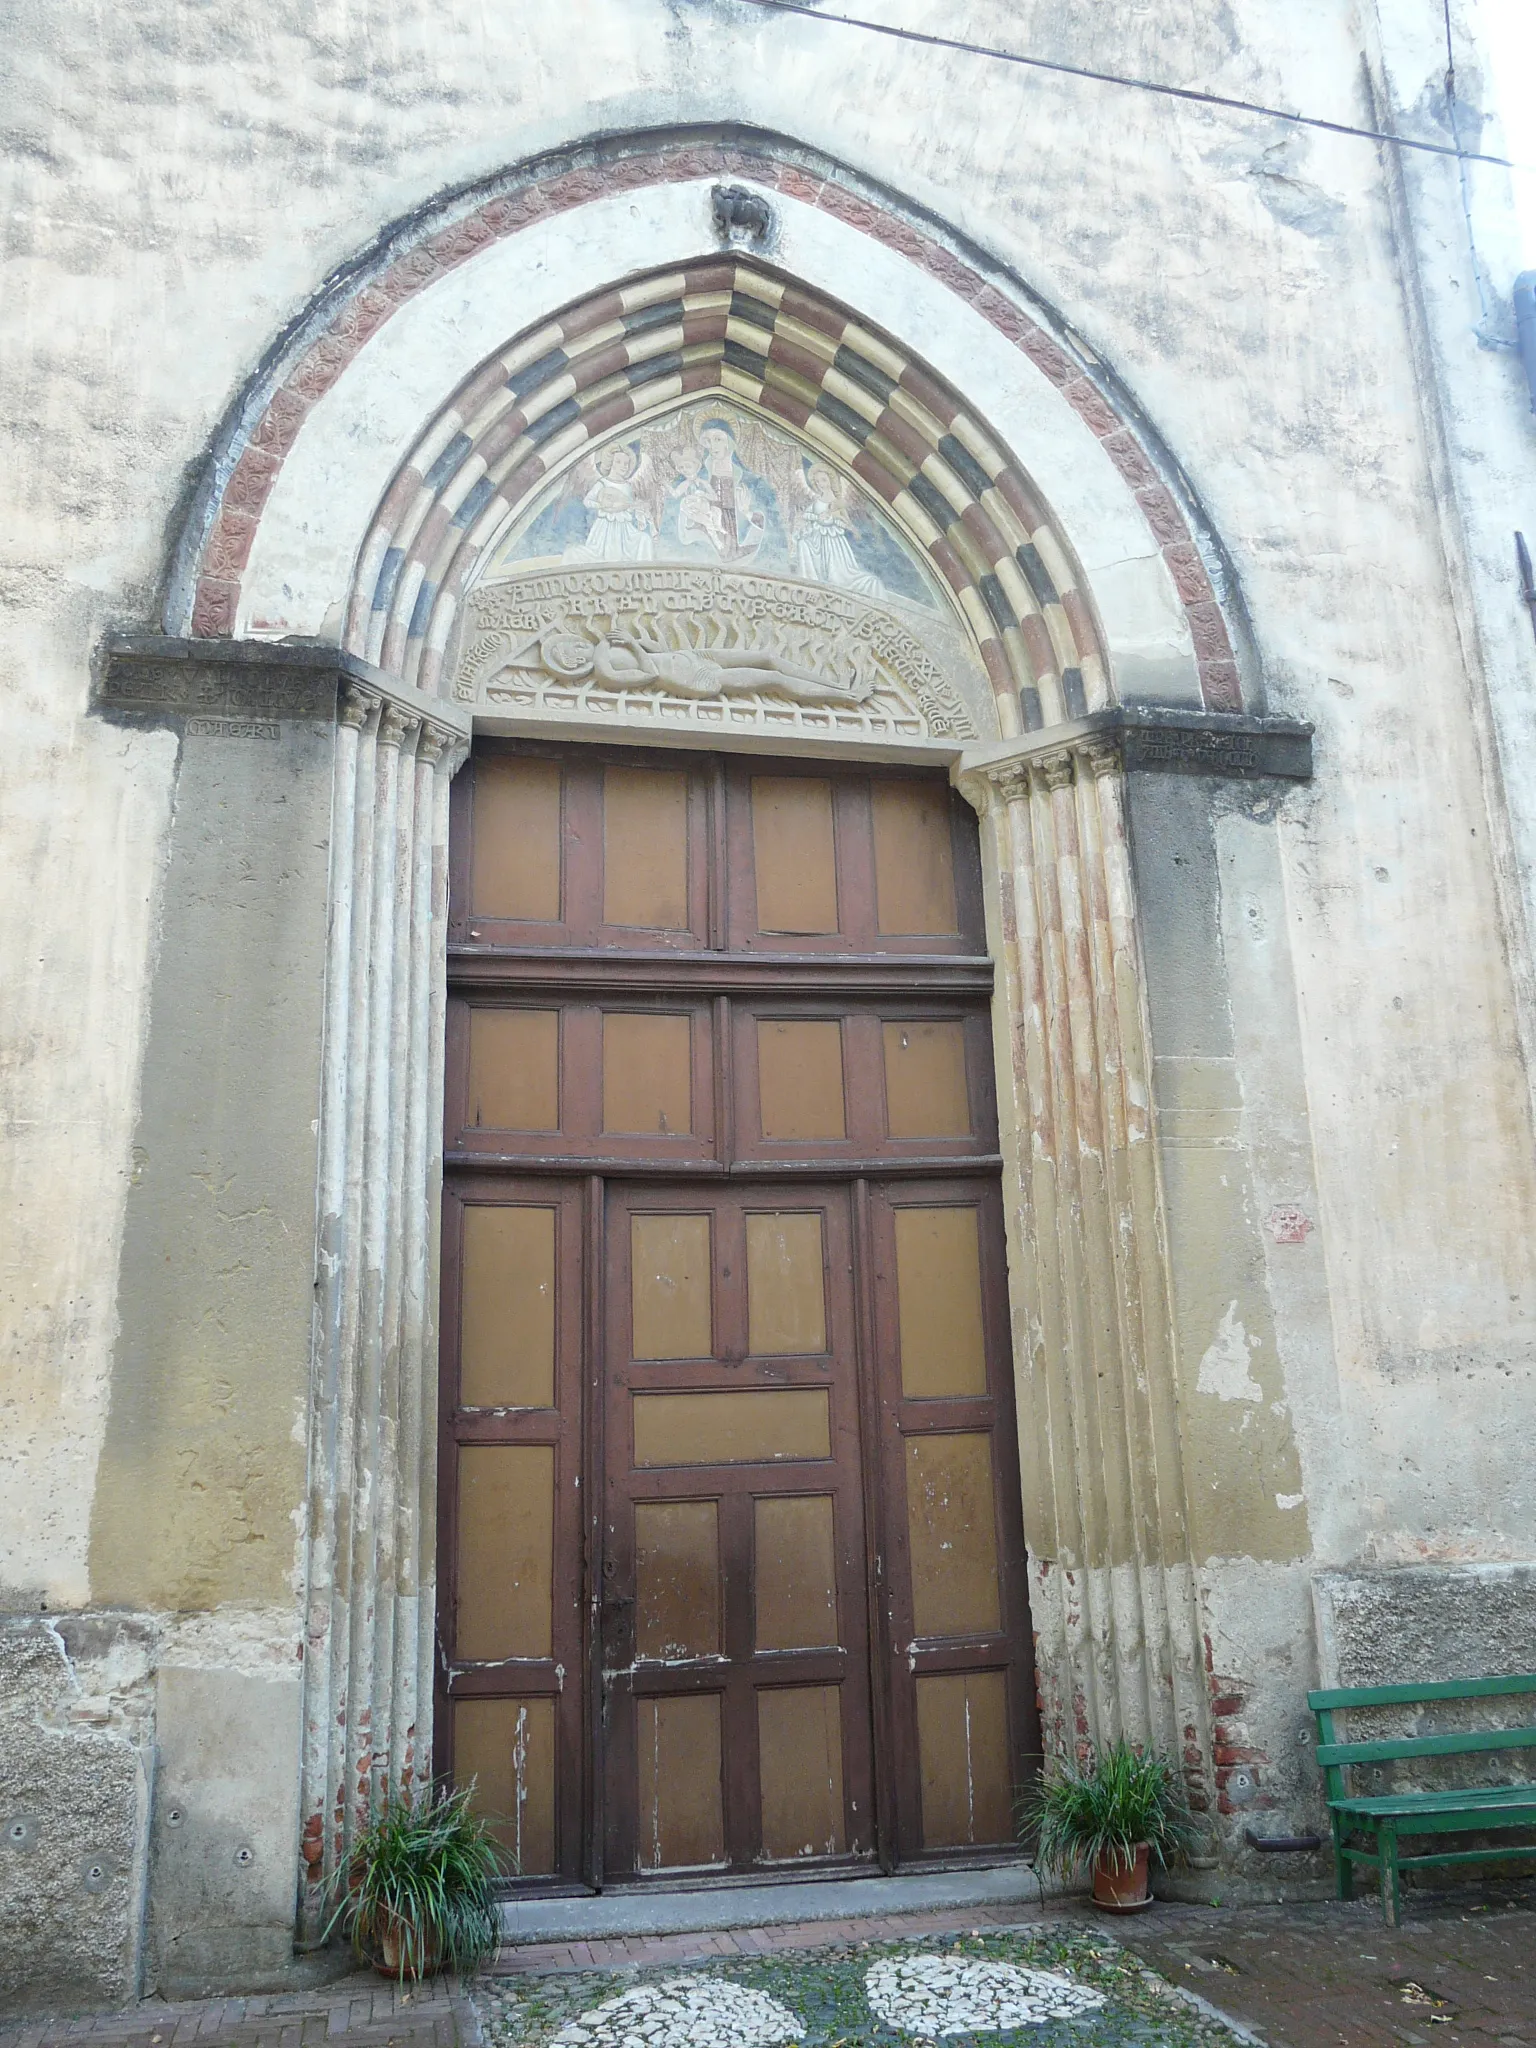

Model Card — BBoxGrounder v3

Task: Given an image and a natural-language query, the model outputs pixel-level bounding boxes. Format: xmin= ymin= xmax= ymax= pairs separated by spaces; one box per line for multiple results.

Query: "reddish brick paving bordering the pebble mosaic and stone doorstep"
xmin=0 ymin=1884 xmax=1536 ymax=2048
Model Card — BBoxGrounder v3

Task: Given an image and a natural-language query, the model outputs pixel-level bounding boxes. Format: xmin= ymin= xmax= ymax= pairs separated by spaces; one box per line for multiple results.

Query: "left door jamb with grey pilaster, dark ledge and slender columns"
xmin=92 ymin=639 xmax=469 ymax=1991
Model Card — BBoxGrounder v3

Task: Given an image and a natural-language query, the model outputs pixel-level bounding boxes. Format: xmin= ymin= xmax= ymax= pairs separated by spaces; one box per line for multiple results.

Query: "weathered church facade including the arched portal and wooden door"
xmin=0 ymin=0 xmax=1536 ymax=2005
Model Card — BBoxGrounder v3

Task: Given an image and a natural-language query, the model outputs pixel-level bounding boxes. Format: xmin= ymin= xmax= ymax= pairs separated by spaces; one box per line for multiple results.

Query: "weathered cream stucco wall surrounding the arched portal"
xmin=0 ymin=0 xmax=1536 ymax=1982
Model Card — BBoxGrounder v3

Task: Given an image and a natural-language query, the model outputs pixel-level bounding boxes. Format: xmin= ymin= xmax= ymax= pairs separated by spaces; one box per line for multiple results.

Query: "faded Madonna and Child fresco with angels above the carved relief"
xmin=485 ymin=397 xmax=936 ymax=610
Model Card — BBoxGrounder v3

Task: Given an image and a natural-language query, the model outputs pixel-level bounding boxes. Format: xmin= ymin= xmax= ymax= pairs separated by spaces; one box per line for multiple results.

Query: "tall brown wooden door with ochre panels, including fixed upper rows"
xmin=436 ymin=745 xmax=1038 ymax=1884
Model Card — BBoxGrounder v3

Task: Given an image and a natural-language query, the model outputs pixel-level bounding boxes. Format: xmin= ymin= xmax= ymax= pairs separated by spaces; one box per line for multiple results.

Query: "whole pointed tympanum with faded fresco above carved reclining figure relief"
xmin=455 ymin=393 xmax=993 ymax=741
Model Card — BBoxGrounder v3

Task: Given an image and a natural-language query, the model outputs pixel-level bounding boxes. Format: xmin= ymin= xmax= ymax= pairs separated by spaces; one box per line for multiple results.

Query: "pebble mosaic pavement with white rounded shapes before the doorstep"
xmin=473 ymin=1925 xmax=1239 ymax=2048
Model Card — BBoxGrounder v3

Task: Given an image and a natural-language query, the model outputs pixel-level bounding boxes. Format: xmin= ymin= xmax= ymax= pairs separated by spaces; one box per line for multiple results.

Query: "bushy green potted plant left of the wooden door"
xmin=326 ymin=1784 xmax=510 ymax=1985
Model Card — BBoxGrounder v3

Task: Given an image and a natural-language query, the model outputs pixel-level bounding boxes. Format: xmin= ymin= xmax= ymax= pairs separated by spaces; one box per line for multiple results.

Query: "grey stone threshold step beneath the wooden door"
xmin=502 ymin=1864 xmax=1042 ymax=1948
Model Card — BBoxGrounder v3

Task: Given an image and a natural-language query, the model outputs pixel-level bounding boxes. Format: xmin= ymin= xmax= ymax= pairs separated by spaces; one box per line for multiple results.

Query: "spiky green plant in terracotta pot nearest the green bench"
xmin=1022 ymin=1737 xmax=1194 ymax=1913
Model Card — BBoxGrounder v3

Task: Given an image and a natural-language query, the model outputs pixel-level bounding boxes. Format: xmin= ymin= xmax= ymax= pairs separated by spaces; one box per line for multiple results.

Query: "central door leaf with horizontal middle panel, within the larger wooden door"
xmin=602 ymin=1186 xmax=874 ymax=1876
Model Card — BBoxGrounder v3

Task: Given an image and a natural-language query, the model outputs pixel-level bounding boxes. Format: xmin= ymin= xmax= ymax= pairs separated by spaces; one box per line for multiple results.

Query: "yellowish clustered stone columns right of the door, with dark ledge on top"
xmin=956 ymin=711 xmax=1311 ymax=1808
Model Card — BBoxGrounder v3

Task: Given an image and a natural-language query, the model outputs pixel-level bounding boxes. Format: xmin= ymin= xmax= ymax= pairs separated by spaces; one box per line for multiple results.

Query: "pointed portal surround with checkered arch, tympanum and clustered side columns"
xmin=100 ymin=139 xmax=1307 ymax=1927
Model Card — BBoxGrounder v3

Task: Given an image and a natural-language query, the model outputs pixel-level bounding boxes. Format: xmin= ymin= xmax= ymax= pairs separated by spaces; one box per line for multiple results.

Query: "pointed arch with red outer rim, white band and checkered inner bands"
xmin=166 ymin=125 xmax=1241 ymax=729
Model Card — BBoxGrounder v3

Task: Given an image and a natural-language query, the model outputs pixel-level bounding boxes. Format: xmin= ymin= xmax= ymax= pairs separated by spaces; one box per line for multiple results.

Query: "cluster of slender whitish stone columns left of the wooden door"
xmin=303 ymin=682 xmax=467 ymax=1935
